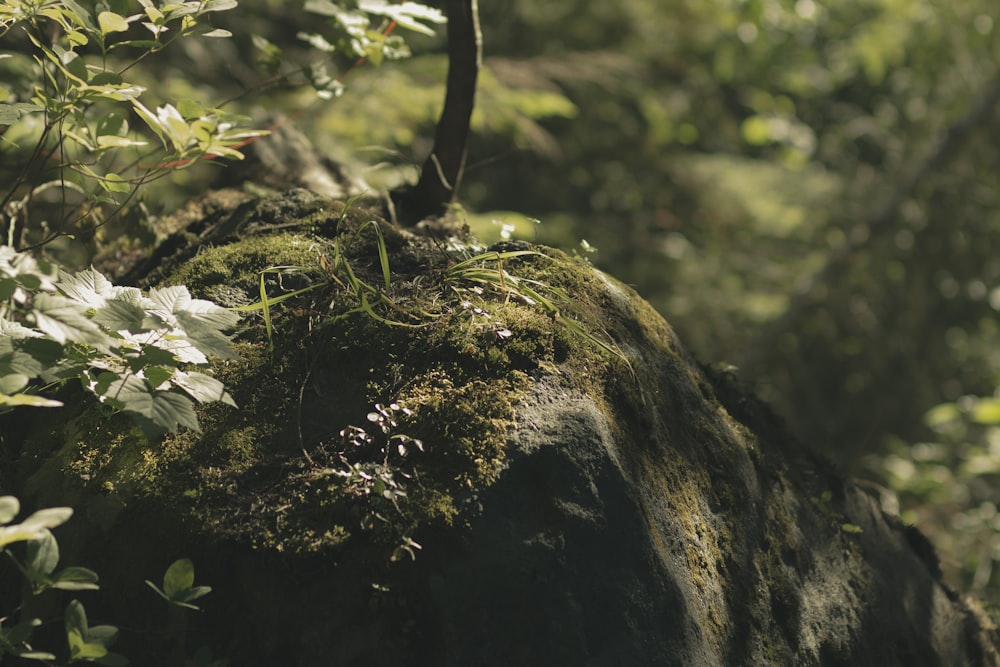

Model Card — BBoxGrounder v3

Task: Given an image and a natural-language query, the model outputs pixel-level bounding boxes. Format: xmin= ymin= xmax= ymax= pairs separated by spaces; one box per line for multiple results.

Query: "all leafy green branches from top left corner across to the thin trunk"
xmin=0 ymin=0 xmax=444 ymax=260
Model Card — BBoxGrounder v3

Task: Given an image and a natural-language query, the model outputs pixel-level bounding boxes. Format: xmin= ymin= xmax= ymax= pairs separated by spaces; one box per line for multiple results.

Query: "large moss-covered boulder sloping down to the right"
xmin=4 ymin=192 xmax=1000 ymax=667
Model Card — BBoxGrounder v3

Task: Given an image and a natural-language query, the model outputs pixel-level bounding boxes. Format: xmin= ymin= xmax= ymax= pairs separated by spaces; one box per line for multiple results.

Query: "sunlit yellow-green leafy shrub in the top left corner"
xmin=0 ymin=0 xmax=261 ymax=249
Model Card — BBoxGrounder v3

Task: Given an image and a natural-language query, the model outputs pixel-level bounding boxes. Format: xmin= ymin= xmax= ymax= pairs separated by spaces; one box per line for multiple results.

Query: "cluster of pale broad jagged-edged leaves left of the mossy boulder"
xmin=0 ymin=246 xmax=238 ymax=434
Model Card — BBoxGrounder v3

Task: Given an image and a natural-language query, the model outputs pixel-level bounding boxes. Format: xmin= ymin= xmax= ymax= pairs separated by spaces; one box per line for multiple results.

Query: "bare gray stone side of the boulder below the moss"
xmin=400 ymin=369 xmax=996 ymax=667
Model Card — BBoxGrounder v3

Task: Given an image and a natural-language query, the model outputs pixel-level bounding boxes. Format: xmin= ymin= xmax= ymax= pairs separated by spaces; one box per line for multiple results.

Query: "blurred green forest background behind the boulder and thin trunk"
xmin=5 ymin=0 xmax=1000 ymax=602
